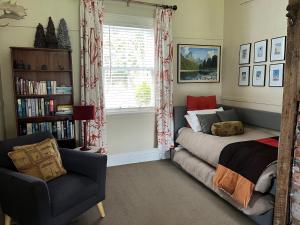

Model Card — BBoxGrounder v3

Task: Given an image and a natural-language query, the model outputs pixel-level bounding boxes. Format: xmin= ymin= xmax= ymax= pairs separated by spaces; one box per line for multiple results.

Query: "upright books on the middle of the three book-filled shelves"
xmin=17 ymin=98 xmax=54 ymax=118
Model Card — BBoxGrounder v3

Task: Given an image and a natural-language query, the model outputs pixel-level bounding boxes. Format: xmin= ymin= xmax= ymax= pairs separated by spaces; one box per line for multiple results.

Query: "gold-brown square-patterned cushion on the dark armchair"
xmin=8 ymin=139 xmax=67 ymax=181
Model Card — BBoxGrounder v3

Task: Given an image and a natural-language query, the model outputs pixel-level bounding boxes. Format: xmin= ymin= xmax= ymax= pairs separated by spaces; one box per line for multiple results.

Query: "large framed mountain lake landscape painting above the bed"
xmin=177 ymin=44 xmax=221 ymax=83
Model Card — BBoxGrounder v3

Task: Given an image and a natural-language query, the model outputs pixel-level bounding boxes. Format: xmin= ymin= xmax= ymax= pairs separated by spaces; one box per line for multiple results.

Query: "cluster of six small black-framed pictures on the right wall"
xmin=238 ymin=36 xmax=286 ymax=87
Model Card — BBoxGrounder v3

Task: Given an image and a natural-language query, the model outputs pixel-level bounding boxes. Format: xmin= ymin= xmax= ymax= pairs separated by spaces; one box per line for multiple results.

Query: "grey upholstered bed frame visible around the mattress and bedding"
xmin=171 ymin=105 xmax=281 ymax=225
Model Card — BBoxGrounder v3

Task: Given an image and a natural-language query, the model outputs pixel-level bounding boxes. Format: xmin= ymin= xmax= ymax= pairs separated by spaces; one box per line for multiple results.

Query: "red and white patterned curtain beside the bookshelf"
xmin=80 ymin=0 xmax=107 ymax=153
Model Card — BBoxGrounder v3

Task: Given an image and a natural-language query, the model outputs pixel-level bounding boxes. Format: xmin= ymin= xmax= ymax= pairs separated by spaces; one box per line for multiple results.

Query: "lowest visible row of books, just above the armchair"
xmin=19 ymin=120 xmax=75 ymax=140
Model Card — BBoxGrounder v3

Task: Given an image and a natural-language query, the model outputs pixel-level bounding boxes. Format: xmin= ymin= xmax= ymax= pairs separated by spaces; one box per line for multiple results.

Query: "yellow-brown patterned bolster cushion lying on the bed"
xmin=211 ymin=121 xmax=244 ymax=137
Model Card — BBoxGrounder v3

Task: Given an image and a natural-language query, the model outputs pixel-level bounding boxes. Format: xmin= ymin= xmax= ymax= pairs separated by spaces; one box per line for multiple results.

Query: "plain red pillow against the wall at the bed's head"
xmin=186 ymin=95 xmax=217 ymax=111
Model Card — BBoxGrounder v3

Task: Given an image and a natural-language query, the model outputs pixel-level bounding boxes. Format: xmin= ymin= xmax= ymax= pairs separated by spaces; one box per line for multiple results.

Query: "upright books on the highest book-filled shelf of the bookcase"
xmin=16 ymin=77 xmax=57 ymax=95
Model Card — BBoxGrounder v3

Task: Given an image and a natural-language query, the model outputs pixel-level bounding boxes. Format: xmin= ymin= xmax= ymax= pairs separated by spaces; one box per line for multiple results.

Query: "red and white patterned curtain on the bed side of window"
xmin=155 ymin=8 xmax=174 ymax=151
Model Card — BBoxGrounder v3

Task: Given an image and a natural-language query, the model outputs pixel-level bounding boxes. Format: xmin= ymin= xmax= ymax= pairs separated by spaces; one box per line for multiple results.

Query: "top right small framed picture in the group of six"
xmin=270 ymin=36 xmax=286 ymax=62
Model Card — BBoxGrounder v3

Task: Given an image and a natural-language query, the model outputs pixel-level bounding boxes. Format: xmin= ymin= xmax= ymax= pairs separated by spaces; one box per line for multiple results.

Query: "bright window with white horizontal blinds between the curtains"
xmin=103 ymin=21 xmax=154 ymax=109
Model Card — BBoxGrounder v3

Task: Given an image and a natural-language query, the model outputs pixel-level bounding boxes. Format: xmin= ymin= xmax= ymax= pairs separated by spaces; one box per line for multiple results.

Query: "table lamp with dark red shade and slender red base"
xmin=73 ymin=105 xmax=96 ymax=151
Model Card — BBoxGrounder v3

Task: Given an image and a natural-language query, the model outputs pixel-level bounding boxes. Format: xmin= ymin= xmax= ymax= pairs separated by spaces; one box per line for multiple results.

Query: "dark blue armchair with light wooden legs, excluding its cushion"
xmin=0 ymin=133 xmax=107 ymax=225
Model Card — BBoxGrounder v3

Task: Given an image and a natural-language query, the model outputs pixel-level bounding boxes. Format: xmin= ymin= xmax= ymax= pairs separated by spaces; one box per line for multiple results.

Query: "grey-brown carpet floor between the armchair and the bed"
xmin=0 ymin=160 xmax=255 ymax=225
